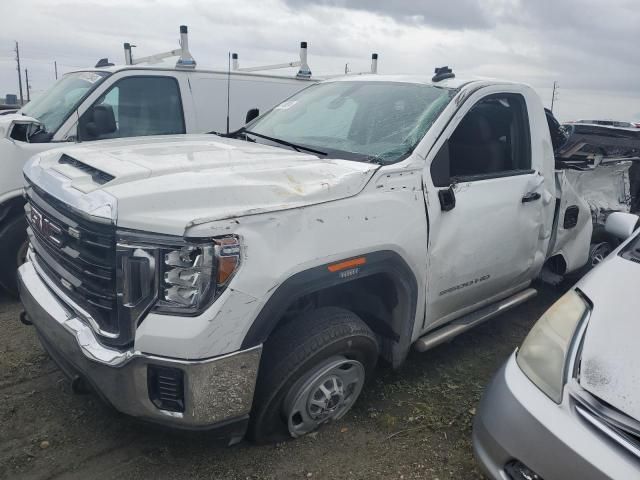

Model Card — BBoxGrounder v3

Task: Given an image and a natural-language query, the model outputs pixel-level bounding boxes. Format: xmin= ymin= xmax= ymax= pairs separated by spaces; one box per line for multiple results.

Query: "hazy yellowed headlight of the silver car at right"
xmin=516 ymin=290 xmax=589 ymax=403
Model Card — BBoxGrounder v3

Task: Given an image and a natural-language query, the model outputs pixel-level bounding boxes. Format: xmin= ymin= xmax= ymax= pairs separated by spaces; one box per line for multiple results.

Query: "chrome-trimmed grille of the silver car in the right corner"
xmin=572 ymin=384 xmax=640 ymax=458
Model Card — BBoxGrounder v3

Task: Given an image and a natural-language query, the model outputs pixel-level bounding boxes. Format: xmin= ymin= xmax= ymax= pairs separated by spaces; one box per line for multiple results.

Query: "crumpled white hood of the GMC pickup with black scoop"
xmin=25 ymin=135 xmax=378 ymax=235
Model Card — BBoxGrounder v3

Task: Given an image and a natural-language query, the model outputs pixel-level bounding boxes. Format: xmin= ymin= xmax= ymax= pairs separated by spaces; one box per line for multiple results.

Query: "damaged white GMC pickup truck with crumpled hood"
xmin=19 ymin=69 xmax=635 ymax=441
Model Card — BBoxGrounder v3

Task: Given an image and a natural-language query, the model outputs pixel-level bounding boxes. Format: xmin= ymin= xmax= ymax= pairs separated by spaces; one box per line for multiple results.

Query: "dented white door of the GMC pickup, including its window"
xmin=425 ymin=84 xmax=554 ymax=329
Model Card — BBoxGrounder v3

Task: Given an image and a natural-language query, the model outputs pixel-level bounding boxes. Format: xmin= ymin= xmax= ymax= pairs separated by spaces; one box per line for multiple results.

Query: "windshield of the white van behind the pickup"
xmin=20 ymin=72 xmax=109 ymax=133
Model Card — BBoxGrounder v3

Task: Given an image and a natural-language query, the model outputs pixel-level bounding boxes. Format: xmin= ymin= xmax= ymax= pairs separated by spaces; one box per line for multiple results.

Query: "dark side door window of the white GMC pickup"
xmin=432 ymin=94 xmax=531 ymax=186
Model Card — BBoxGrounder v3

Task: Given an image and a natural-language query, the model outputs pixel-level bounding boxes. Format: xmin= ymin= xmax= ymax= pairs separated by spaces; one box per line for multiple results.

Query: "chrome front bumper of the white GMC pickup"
xmin=18 ymin=262 xmax=262 ymax=429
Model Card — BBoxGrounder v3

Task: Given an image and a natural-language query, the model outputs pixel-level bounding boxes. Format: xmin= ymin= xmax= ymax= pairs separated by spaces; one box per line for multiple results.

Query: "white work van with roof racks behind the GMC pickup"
xmin=0 ymin=26 xmax=316 ymax=293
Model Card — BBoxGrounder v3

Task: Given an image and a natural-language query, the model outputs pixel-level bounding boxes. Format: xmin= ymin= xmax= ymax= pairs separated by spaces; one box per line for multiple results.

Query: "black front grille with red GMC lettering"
xmin=25 ymin=181 xmax=129 ymax=345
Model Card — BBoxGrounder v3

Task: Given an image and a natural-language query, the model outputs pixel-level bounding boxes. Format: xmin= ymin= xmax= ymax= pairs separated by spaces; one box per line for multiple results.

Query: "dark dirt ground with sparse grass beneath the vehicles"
xmin=0 ymin=288 xmax=560 ymax=480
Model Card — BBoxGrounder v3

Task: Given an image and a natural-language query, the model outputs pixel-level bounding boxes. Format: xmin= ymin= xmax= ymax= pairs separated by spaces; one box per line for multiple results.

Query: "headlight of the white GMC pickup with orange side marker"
xmin=117 ymin=235 xmax=240 ymax=318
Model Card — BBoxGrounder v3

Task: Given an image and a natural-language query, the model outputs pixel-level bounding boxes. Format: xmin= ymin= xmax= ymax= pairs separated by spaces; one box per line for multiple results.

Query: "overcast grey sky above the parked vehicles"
xmin=0 ymin=0 xmax=640 ymax=121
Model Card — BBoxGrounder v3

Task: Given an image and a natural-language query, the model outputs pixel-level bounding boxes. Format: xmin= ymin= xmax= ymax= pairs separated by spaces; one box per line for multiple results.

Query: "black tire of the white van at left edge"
xmin=0 ymin=215 xmax=29 ymax=297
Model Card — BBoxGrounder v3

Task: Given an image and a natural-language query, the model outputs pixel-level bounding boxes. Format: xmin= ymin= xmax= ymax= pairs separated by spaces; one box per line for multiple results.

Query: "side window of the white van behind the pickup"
xmin=78 ymin=76 xmax=185 ymax=140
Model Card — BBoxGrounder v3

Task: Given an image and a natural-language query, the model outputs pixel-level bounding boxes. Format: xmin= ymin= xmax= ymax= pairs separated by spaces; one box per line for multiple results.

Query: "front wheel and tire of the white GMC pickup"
xmin=248 ymin=307 xmax=378 ymax=443
